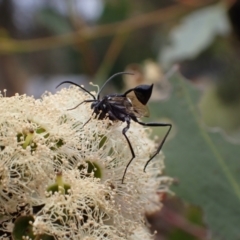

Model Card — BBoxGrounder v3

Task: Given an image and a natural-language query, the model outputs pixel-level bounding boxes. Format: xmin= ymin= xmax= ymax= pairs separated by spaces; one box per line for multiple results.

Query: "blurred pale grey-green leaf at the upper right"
xmin=160 ymin=3 xmax=231 ymax=65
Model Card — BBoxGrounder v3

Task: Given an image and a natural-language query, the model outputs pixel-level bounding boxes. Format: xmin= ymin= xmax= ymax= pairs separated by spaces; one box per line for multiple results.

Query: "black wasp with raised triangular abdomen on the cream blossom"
xmin=57 ymin=72 xmax=172 ymax=183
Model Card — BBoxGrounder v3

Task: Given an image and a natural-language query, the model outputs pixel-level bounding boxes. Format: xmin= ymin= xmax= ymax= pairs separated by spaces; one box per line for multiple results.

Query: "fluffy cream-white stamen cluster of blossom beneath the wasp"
xmin=0 ymin=87 xmax=171 ymax=240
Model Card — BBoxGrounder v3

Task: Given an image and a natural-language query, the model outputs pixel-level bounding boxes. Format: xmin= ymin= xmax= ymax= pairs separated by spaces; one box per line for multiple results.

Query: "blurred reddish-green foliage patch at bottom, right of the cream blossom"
xmin=147 ymin=196 xmax=208 ymax=240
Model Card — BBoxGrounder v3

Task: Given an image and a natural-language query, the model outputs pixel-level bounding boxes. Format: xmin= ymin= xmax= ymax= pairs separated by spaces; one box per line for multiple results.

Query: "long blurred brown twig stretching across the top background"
xmin=0 ymin=0 xmax=216 ymax=54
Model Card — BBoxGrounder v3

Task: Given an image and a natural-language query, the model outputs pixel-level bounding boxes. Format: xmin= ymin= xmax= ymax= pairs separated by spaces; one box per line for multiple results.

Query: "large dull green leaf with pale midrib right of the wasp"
xmin=150 ymin=76 xmax=240 ymax=240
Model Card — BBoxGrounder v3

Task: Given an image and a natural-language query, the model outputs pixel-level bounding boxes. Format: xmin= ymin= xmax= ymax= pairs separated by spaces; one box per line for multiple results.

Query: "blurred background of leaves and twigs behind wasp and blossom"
xmin=0 ymin=0 xmax=240 ymax=240
